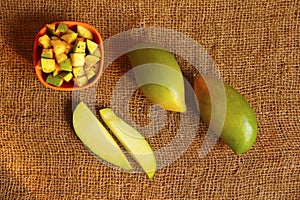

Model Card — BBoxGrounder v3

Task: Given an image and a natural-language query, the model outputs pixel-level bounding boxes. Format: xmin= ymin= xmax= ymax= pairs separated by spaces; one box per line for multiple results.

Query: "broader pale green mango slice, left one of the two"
xmin=73 ymin=102 xmax=132 ymax=170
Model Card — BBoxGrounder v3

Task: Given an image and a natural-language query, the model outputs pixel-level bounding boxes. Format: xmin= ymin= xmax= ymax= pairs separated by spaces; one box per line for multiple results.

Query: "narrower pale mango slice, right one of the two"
xmin=100 ymin=108 xmax=156 ymax=179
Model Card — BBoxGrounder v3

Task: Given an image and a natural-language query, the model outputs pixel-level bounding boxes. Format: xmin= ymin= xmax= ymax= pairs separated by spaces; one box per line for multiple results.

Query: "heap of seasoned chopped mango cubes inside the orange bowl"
xmin=38 ymin=22 xmax=101 ymax=87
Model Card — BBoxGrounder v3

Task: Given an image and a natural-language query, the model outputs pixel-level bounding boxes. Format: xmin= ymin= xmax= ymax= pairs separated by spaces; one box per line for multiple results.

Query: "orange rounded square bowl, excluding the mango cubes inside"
xmin=33 ymin=21 xmax=104 ymax=91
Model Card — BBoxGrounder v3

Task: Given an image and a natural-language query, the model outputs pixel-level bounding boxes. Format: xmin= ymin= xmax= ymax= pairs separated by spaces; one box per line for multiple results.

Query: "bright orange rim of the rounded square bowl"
xmin=33 ymin=20 xmax=104 ymax=91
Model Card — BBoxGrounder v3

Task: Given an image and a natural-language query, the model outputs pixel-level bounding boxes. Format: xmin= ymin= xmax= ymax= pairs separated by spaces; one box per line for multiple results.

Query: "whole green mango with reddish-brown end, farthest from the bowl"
xmin=194 ymin=75 xmax=257 ymax=155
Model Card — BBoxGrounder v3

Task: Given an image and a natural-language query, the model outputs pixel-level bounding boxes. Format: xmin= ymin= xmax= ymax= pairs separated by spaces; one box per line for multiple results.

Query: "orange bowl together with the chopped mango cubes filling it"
xmin=33 ymin=21 xmax=104 ymax=91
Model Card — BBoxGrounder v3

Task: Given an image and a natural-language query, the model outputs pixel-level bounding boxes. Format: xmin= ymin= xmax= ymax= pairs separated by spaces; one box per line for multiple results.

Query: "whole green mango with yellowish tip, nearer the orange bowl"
xmin=127 ymin=43 xmax=186 ymax=112
